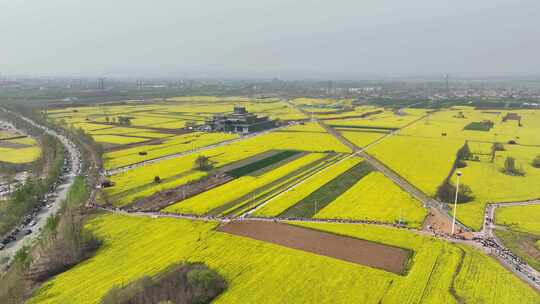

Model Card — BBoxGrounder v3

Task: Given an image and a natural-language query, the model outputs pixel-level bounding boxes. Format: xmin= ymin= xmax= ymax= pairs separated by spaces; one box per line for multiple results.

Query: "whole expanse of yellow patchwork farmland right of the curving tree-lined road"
xmin=11 ymin=96 xmax=540 ymax=303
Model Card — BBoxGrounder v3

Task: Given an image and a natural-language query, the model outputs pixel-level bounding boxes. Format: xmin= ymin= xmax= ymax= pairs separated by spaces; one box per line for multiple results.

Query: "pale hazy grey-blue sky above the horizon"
xmin=0 ymin=0 xmax=540 ymax=78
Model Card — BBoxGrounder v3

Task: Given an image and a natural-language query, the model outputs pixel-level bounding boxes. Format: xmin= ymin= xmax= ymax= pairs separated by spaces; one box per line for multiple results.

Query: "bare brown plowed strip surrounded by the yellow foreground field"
xmin=219 ymin=221 xmax=410 ymax=274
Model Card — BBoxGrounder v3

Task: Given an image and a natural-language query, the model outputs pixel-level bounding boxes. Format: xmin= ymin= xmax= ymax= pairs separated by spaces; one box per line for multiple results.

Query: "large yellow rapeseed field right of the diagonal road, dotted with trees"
xmin=374 ymin=107 xmax=540 ymax=229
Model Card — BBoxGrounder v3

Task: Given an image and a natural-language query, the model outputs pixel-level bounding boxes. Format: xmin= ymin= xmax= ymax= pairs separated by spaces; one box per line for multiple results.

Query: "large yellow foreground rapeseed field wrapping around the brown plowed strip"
xmin=29 ymin=215 xmax=540 ymax=304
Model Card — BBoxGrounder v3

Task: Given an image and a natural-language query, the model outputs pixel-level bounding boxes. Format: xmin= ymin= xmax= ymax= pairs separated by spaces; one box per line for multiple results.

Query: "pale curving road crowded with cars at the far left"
xmin=0 ymin=109 xmax=82 ymax=260
